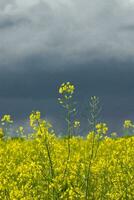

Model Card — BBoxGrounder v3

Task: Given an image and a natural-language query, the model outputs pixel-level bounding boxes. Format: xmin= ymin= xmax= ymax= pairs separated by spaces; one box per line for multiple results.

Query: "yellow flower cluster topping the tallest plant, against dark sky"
xmin=59 ymin=82 xmax=75 ymax=94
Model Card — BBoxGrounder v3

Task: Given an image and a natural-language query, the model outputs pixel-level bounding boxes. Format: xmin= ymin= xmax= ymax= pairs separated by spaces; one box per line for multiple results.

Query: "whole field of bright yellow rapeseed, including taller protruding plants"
xmin=0 ymin=83 xmax=134 ymax=200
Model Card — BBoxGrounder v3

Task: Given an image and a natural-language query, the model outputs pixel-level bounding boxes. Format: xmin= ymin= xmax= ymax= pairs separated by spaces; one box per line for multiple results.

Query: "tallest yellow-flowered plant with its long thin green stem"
xmin=58 ymin=82 xmax=80 ymax=192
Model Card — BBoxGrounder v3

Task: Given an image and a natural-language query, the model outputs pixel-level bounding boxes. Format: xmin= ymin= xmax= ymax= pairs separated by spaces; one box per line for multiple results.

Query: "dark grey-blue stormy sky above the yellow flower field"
xmin=0 ymin=0 xmax=134 ymax=134
